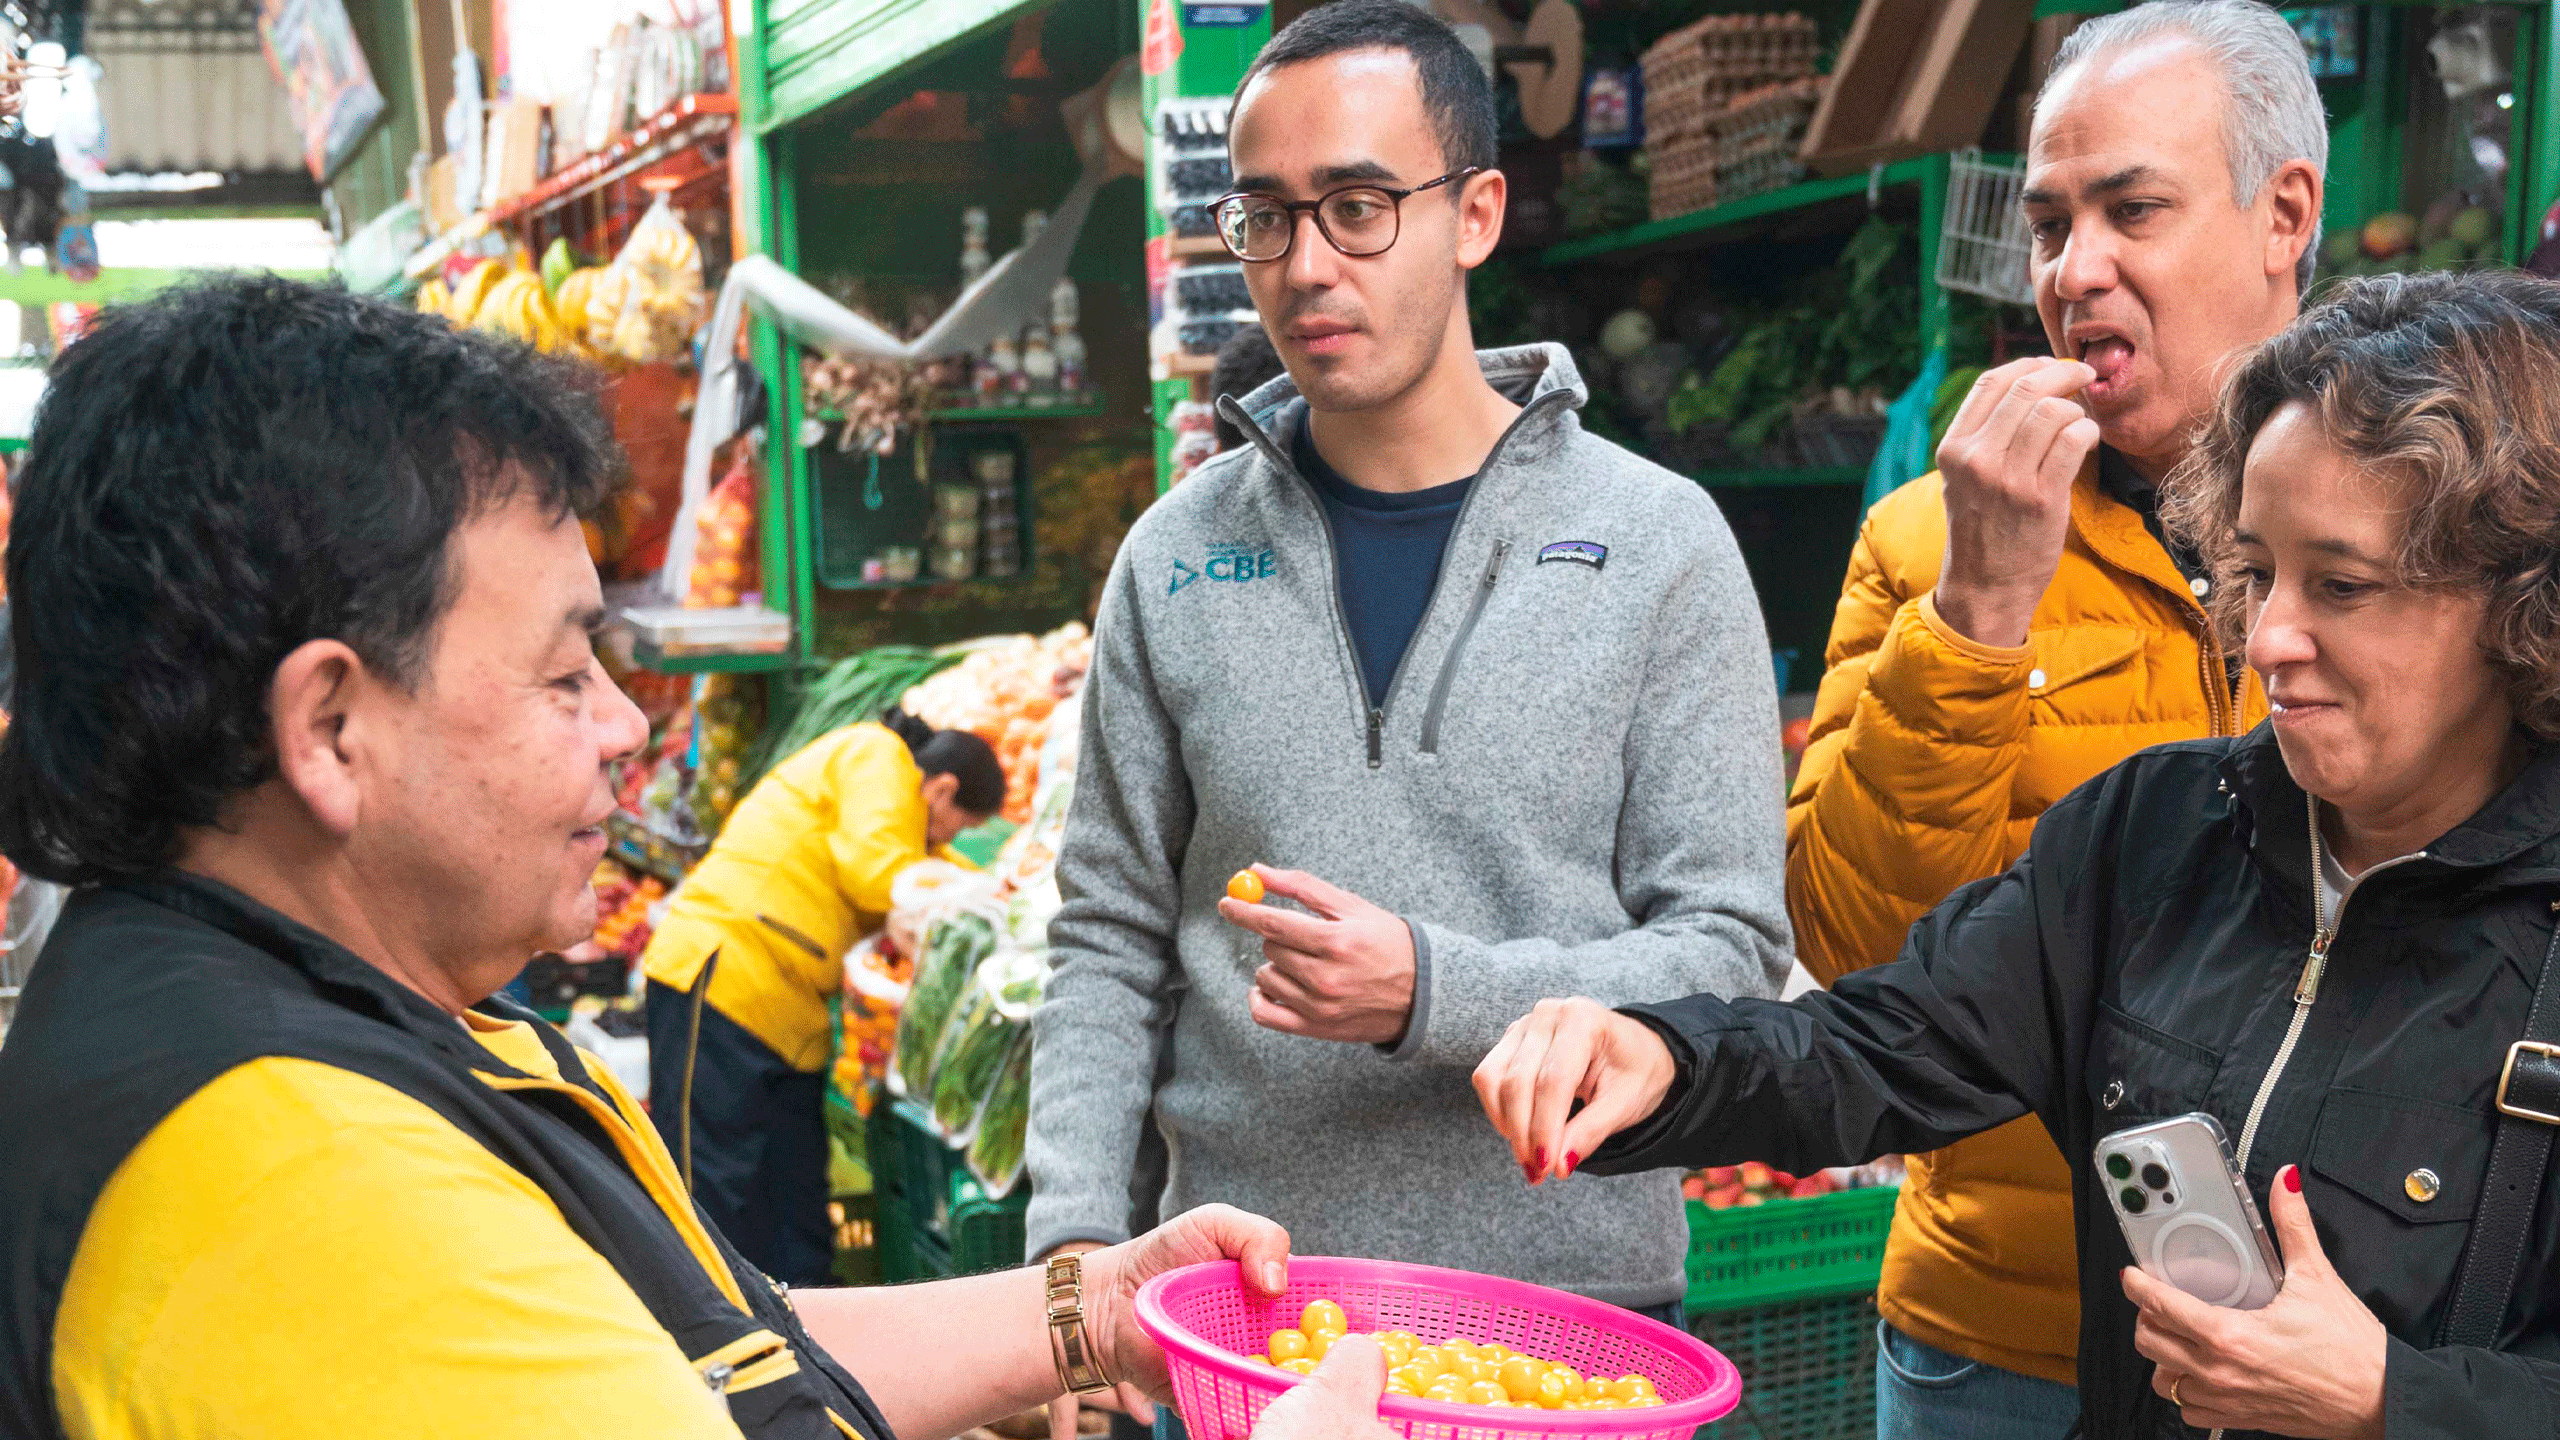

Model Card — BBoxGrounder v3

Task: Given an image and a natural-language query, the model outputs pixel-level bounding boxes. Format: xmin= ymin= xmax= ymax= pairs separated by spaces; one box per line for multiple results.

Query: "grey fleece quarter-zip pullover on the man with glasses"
xmin=1029 ymin=346 xmax=1789 ymax=1304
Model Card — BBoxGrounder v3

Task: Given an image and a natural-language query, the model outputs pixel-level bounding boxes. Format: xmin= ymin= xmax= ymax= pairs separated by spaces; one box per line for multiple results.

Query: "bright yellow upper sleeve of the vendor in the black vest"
xmin=54 ymin=1058 xmax=737 ymax=1440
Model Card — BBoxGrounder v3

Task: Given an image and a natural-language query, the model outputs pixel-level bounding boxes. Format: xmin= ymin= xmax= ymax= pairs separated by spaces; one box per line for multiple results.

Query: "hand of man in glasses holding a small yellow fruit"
xmin=1219 ymin=866 xmax=1413 ymax=1045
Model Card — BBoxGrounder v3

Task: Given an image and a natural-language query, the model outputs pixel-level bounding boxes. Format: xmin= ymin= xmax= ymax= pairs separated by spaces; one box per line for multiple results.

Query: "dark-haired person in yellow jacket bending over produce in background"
xmin=640 ymin=710 xmax=1004 ymax=1284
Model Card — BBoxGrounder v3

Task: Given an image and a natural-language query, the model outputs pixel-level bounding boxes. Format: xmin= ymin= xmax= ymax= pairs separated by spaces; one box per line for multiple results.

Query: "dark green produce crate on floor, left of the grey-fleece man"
xmin=870 ymin=1094 xmax=1032 ymax=1284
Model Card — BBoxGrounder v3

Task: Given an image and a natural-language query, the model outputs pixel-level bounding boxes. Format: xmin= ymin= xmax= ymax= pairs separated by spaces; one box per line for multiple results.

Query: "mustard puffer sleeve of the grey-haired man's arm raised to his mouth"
xmin=1787 ymin=482 xmax=2033 ymax=984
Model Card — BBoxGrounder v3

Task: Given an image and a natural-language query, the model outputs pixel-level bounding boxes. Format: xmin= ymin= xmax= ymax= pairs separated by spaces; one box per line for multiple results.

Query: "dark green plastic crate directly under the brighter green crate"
xmin=1690 ymin=1289 xmax=1876 ymax=1440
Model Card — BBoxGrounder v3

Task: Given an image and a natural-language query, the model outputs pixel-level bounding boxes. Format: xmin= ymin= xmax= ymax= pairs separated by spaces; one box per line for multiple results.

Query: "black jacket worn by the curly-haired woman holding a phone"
xmin=1587 ymin=725 xmax=2560 ymax=1440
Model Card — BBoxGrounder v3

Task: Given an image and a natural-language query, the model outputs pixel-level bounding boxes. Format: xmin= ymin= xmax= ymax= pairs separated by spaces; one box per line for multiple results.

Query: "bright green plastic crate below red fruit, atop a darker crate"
xmin=1690 ymin=1186 xmax=1902 ymax=1314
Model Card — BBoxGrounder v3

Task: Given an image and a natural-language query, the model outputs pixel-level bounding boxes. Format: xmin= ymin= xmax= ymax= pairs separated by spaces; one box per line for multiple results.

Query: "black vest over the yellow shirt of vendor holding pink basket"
xmin=0 ymin=874 xmax=893 ymax=1440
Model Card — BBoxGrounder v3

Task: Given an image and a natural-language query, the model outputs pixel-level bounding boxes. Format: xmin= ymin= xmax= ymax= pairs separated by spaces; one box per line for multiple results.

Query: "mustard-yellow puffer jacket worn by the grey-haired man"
xmin=1787 ymin=464 xmax=2266 ymax=1384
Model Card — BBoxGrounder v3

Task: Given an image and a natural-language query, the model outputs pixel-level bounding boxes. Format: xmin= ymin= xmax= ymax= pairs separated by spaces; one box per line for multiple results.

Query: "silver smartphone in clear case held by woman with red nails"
xmin=2094 ymin=1112 xmax=2284 ymax=1309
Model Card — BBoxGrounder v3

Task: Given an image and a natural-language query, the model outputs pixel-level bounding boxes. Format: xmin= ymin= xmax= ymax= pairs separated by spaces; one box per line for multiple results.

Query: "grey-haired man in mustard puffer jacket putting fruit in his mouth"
xmin=1787 ymin=0 xmax=2330 ymax=1440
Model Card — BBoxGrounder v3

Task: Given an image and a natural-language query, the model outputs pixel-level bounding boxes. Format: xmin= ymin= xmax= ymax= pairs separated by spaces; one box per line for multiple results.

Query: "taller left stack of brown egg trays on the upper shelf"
xmin=1644 ymin=13 xmax=1818 ymax=220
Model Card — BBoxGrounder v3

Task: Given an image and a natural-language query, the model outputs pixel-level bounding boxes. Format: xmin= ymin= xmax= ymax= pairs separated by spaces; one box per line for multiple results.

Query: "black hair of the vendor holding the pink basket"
xmin=0 ymin=274 xmax=620 ymax=884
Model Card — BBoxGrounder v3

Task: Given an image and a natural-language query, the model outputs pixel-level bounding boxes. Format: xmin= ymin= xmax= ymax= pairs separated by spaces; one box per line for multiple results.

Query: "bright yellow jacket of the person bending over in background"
xmin=640 ymin=725 xmax=957 ymax=1071
